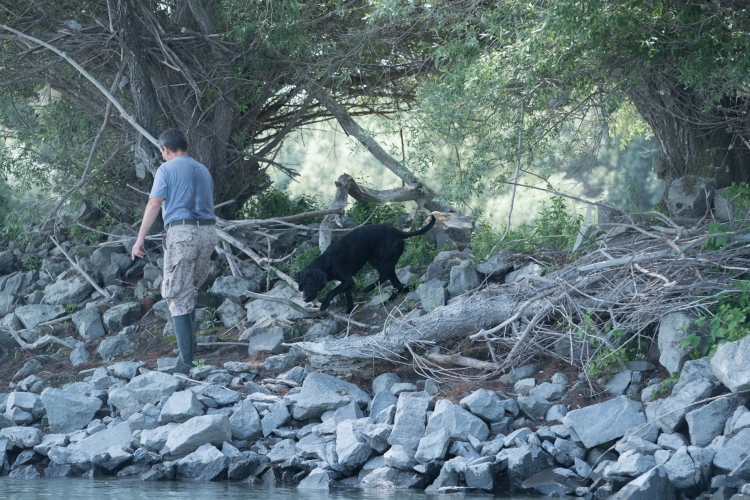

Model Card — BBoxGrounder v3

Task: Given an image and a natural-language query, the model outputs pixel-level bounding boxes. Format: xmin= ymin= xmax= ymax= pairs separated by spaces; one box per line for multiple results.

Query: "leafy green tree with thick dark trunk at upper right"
xmin=394 ymin=0 xmax=750 ymax=203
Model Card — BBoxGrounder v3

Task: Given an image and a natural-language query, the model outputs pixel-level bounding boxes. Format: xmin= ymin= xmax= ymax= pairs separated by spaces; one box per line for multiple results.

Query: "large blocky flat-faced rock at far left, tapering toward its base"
xmin=40 ymin=387 xmax=102 ymax=434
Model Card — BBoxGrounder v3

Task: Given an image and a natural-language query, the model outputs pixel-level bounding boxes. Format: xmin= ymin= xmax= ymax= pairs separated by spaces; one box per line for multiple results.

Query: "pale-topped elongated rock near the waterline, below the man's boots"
xmin=163 ymin=414 xmax=232 ymax=460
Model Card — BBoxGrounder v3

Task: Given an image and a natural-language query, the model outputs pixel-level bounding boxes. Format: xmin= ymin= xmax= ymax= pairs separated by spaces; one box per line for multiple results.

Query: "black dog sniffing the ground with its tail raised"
xmin=299 ymin=216 xmax=435 ymax=313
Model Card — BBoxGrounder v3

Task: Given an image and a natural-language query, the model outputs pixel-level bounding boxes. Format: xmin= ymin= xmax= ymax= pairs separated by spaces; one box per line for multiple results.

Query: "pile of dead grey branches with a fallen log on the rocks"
xmin=298 ymin=213 xmax=750 ymax=378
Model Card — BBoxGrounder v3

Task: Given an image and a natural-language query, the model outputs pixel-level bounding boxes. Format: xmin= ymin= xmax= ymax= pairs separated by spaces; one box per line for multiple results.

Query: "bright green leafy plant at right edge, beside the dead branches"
xmin=682 ymin=281 xmax=750 ymax=358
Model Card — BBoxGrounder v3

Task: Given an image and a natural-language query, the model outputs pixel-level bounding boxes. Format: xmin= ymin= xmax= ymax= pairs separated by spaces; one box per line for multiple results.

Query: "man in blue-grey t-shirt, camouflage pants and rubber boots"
xmin=131 ymin=129 xmax=217 ymax=372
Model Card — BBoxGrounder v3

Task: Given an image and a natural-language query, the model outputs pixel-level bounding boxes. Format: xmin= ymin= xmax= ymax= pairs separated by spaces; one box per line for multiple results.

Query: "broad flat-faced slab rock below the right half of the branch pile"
xmin=563 ymin=396 xmax=646 ymax=448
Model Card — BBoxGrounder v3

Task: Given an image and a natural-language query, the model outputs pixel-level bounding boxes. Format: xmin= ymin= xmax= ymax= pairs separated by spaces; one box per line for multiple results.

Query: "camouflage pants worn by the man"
xmin=161 ymin=226 xmax=218 ymax=316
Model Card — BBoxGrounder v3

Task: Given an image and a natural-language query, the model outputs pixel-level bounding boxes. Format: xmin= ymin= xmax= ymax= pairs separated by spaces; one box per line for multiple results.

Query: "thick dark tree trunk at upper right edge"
xmin=629 ymin=73 xmax=750 ymax=188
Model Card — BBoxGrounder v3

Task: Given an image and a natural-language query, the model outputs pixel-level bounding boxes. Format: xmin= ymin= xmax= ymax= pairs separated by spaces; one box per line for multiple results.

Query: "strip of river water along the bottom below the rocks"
xmin=0 ymin=477 xmax=546 ymax=500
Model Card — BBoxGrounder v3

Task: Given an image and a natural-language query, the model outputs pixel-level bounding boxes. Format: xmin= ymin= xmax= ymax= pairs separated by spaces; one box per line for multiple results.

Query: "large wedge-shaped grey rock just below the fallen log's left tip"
xmin=292 ymin=372 xmax=370 ymax=420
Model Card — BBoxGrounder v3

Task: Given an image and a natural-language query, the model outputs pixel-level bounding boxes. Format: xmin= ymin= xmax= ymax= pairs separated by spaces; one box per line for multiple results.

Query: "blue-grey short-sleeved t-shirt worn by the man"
xmin=149 ymin=156 xmax=216 ymax=225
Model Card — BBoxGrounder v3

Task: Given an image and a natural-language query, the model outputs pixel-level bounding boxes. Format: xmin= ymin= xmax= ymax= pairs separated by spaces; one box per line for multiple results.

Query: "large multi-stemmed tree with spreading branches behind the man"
xmin=0 ymin=0 xmax=438 ymax=221
